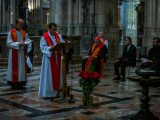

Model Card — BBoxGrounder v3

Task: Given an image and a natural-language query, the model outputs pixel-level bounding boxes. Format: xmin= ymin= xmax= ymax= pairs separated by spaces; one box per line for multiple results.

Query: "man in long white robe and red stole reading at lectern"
xmin=38 ymin=23 xmax=65 ymax=99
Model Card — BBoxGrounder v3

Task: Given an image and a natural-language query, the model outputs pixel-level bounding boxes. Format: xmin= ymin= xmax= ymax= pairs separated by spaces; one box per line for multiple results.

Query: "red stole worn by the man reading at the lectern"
xmin=43 ymin=32 xmax=61 ymax=89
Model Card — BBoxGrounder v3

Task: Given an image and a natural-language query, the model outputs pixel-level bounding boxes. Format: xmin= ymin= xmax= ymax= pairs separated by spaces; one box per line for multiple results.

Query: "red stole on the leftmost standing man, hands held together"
xmin=10 ymin=29 xmax=26 ymax=82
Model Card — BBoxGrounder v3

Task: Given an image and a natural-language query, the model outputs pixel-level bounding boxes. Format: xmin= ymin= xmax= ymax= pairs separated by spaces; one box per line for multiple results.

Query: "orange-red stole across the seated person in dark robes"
xmin=85 ymin=42 xmax=104 ymax=71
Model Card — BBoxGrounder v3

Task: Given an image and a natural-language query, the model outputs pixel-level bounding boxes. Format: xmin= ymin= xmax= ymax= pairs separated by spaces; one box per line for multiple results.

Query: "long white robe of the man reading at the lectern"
xmin=38 ymin=31 xmax=64 ymax=97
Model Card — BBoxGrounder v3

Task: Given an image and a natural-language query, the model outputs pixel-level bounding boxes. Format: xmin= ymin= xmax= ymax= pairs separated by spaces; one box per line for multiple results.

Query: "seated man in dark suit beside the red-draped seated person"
xmin=113 ymin=36 xmax=137 ymax=81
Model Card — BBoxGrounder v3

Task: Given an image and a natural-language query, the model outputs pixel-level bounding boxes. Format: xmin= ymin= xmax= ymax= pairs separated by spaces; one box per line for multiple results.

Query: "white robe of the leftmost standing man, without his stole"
xmin=6 ymin=30 xmax=32 ymax=82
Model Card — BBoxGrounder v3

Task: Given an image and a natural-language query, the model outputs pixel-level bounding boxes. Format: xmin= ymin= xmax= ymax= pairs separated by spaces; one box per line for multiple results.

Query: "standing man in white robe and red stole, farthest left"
xmin=6 ymin=18 xmax=32 ymax=89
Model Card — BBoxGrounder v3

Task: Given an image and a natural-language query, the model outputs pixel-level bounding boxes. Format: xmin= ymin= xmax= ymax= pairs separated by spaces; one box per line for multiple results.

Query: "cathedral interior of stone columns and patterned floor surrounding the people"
xmin=0 ymin=0 xmax=160 ymax=120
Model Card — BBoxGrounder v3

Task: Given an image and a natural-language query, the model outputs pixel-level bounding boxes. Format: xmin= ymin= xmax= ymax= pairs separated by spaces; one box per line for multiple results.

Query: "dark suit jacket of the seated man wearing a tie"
xmin=121 ymin=44 xmax=137 ymax=67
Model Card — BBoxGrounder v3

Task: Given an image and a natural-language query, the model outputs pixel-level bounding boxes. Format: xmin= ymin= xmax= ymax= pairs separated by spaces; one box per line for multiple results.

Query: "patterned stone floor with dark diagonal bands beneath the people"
xmin=0 ymin=65 xmax=160 ymax=120
